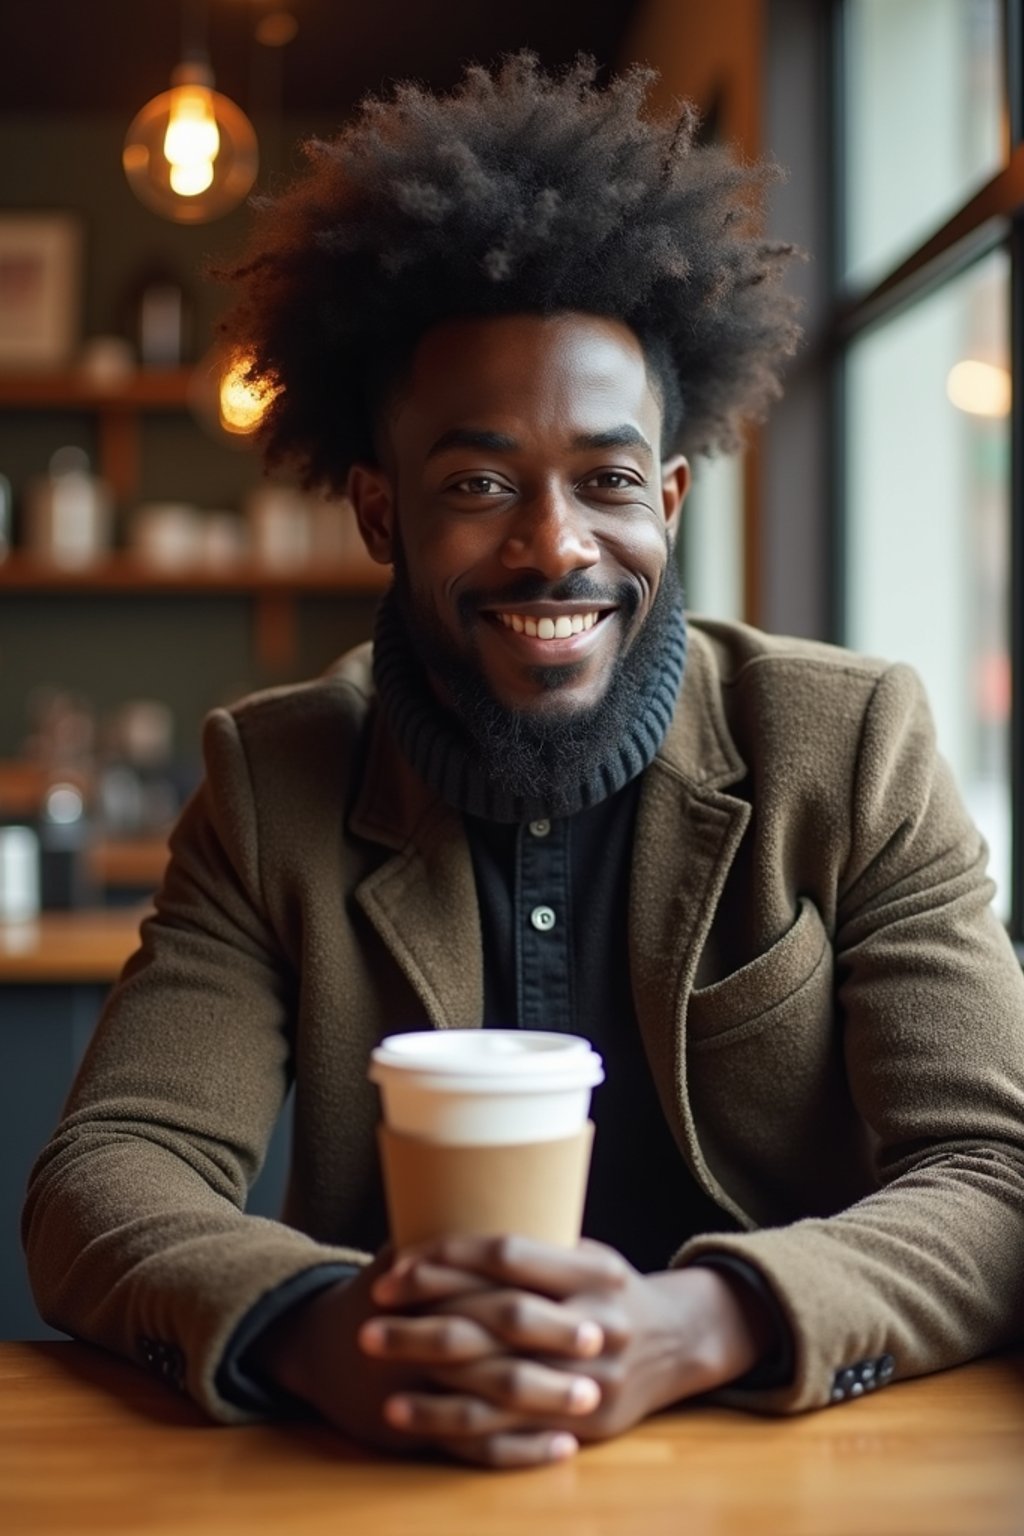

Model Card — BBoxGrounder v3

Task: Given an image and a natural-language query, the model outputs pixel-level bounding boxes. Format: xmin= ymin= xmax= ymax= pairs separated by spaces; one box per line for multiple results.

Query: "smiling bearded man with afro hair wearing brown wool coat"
xmin=25 ymin=57 xmax=1024 ymax=1465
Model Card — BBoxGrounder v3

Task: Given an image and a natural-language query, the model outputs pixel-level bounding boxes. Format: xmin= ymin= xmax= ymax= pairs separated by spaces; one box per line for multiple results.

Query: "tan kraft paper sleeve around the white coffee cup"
xmin=378 ymin=1121 xmax=594 ymax=1249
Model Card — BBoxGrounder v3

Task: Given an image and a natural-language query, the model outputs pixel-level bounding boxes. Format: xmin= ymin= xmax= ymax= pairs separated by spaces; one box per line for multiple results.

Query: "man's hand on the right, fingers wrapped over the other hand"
xmin=361 ymin=1236 xmax=771 ymax=1464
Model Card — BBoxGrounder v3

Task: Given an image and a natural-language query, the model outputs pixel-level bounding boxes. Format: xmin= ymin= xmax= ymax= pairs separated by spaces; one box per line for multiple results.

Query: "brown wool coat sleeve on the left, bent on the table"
xmin=23 ymin=711 xmax=367 ymax=1421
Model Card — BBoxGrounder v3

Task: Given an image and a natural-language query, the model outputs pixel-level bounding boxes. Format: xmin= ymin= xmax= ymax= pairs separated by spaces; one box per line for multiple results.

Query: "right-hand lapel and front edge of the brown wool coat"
xmin=629 ymin=630 xmax=751 ymax=1227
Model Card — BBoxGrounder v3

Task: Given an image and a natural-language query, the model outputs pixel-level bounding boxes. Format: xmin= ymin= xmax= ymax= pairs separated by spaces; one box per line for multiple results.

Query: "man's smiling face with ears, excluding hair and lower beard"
xmin=348 ymin=313 xmax=689 ymax=722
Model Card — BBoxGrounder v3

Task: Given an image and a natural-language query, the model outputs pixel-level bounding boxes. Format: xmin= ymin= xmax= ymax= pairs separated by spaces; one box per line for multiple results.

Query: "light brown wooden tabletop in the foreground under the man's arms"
xmin=0 ymin=1342 xmax=1024 ymax=1536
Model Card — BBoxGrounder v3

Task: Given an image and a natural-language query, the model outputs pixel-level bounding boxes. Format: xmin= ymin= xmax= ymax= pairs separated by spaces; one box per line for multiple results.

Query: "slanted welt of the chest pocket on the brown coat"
xmin=686 ymin=895 xmax=829 ymax=1051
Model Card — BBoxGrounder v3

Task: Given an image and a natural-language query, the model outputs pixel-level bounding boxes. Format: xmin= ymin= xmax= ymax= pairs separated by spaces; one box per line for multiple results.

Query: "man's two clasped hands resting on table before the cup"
xmin=255 ymin=1236 xmax=768 ymax=1467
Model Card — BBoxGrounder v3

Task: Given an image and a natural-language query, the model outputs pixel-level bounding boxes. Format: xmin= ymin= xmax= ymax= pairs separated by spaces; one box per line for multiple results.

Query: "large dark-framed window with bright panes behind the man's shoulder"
xmin=832 ymin=0 xmax=1024 ymax=943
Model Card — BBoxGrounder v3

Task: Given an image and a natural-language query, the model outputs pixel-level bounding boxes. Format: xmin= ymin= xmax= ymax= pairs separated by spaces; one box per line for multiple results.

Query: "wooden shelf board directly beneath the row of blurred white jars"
xmin=0 ymin=553 xmax=388 ymax=596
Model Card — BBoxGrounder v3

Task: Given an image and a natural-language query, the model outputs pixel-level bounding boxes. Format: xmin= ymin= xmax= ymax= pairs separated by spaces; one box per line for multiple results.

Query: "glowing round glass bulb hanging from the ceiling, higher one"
xmin=121 ymin=60 xmax=259 ymax=224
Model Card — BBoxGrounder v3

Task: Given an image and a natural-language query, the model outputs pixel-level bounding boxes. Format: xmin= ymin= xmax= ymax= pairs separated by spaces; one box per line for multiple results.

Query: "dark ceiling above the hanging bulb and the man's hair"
xmin=8 ymin=0 xmax=640 ymax=117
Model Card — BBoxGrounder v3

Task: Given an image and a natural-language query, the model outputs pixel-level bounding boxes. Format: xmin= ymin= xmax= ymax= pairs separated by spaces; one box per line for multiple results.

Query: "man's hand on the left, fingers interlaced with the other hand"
xmin=247 ymin=1250 xmax=617 ymax=1467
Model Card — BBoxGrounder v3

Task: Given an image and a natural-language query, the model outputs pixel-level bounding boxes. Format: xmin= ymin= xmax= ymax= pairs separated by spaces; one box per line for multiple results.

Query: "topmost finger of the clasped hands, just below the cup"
xmin=375 ymin=1235 xmax=629 ymax=1301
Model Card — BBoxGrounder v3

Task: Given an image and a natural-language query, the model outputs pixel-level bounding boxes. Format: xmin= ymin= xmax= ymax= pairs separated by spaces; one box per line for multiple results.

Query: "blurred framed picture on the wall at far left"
xmin=0 ymin=212 xmax=81 ymax=372
